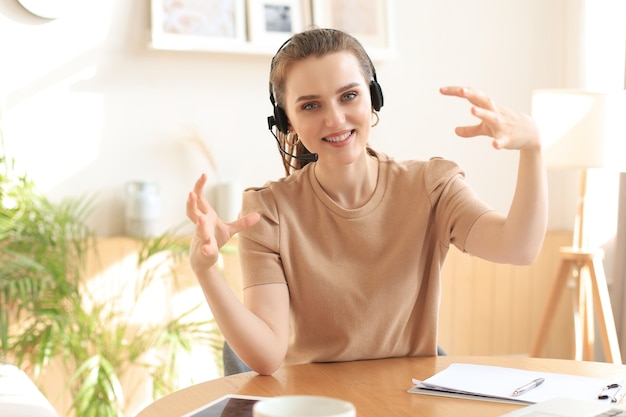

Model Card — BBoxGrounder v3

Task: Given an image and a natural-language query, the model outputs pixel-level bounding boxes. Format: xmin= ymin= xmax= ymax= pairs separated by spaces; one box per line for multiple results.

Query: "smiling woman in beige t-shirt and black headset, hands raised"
xmin=187 ymin=29 xmax=547 ymax=374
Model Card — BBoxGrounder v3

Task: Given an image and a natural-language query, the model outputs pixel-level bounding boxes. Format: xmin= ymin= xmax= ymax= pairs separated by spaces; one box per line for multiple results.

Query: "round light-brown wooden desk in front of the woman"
xmin=137 ymin=356 xmax=626 ymax=417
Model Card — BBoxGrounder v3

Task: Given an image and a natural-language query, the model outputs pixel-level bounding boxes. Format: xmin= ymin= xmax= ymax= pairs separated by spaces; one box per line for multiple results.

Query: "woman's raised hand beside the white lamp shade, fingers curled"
xmin=439 ymin=86 xmax=541 ymax=149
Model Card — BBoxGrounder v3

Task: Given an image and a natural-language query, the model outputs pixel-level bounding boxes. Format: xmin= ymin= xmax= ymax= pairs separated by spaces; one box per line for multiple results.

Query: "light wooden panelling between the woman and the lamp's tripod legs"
xmin=439 ymin=231 xmax=574 ymax=359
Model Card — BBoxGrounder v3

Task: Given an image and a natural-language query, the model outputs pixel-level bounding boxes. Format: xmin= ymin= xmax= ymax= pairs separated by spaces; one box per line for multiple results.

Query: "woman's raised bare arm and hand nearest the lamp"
xmin=441 ymin=87 xmax=548 ymax=264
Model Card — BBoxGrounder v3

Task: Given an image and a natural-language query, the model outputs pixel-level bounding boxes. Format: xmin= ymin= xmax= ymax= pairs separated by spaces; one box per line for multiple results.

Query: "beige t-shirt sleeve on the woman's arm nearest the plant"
xmin=237 ymin=185 xmax=285 ymax=289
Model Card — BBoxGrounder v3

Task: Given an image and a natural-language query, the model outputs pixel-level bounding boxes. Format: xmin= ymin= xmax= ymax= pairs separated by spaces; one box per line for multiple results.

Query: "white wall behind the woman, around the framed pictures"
xmin=0 ymin=0 xmax=579 ymax=235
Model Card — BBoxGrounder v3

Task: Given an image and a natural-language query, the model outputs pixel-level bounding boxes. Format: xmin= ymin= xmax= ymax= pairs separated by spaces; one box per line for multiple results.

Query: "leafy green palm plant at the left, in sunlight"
xmin=0 ymin=131 xmax=223 ymax=417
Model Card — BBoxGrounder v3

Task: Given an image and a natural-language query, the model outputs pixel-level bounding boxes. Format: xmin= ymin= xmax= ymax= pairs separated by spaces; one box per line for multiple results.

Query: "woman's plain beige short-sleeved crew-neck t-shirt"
xmin=239 ymin=153 xmax=490 ymax=364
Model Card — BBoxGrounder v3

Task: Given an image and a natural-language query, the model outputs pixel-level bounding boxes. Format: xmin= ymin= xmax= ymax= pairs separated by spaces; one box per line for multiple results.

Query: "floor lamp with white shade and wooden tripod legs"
xmin=530 ymin=90 xmax=626 ymax=364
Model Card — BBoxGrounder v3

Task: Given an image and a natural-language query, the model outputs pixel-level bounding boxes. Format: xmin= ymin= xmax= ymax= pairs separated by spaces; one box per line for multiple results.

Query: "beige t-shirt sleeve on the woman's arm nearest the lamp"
xmin=424 ymin=158 xmax=493 ymax=252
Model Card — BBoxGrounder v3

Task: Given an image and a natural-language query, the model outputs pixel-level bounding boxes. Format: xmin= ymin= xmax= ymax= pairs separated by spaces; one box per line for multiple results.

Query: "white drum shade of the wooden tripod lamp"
xmin=532 ymin=89 xmax=626 ymax=172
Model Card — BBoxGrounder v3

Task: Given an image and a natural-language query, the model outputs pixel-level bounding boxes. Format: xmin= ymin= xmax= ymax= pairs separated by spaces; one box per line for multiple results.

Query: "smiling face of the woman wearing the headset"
xmin=284 ymin=52 xmax=372 ymax=165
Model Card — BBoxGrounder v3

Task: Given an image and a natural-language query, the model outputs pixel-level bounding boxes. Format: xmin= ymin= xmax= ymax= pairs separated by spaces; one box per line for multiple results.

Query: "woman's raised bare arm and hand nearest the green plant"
xmin=187 ymin=175 xmax=289 ymax=375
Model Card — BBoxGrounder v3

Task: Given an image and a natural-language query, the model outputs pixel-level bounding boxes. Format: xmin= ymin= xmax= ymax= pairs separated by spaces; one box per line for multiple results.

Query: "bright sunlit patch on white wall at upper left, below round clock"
xmin=0 ymin=2 xmax=112 ymax=191
